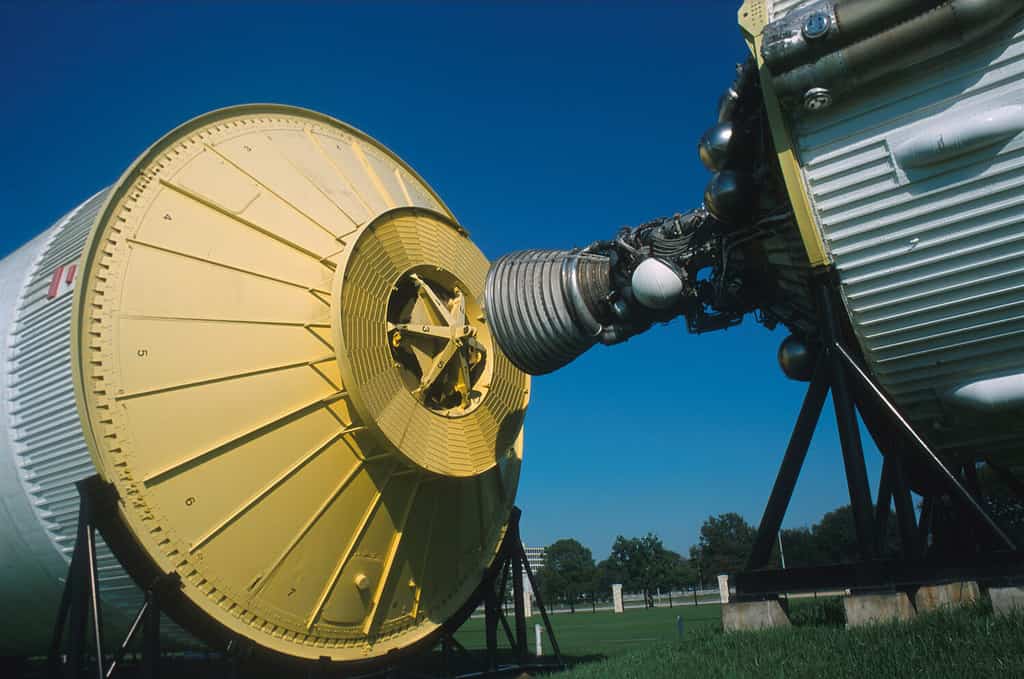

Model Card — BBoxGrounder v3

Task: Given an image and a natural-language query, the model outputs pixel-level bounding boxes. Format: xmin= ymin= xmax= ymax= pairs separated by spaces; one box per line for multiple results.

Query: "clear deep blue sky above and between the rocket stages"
xmin=0 ymin=0 xmax=880 ymax=558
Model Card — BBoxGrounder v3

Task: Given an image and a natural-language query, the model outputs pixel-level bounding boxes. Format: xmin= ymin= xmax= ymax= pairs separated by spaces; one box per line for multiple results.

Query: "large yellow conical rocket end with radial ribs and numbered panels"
xmin=72 ymin=104 xmax=527 ymax=662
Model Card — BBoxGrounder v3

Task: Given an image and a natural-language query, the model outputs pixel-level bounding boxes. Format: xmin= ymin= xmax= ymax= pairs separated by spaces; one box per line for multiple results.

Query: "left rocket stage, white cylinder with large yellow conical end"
xmin=0 ymin=104 xmax=529 ymax=663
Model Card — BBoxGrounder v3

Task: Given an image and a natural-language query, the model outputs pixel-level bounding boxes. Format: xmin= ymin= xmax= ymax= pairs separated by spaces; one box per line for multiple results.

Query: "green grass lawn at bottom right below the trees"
xmin=458 ymin=599 xmax=1024 ymax=679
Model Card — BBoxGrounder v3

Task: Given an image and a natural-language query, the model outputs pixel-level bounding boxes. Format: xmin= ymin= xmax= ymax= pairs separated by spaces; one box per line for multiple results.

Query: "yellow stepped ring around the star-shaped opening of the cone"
xmin=333 ymin=210 xmax=527 ymax=477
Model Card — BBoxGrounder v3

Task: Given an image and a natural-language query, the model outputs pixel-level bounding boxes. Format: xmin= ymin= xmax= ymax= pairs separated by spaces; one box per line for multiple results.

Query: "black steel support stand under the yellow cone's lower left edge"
xmin=47 ymin=476 xmax=176 ymax=679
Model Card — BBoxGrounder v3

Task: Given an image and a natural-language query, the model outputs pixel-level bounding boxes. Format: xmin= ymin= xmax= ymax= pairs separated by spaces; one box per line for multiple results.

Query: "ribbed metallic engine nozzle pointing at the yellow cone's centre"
xmin=484 ymin=250 xmax=610 ymax=375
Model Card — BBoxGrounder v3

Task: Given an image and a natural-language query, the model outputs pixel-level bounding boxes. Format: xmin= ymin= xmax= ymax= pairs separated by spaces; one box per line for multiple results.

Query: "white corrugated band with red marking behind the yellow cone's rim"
xmin=5 ymin=189 xmax=190 ymax=644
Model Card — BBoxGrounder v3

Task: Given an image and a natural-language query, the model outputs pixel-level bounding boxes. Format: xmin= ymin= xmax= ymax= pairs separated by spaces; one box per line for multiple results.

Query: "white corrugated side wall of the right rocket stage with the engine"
xmin=797 ymin=17 xmax=1024 ymax=462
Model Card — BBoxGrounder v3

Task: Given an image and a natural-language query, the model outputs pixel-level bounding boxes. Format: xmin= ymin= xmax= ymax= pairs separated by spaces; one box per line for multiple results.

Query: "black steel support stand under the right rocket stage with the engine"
xmin=735 ymin=273 xmax=1024 ymax=597
